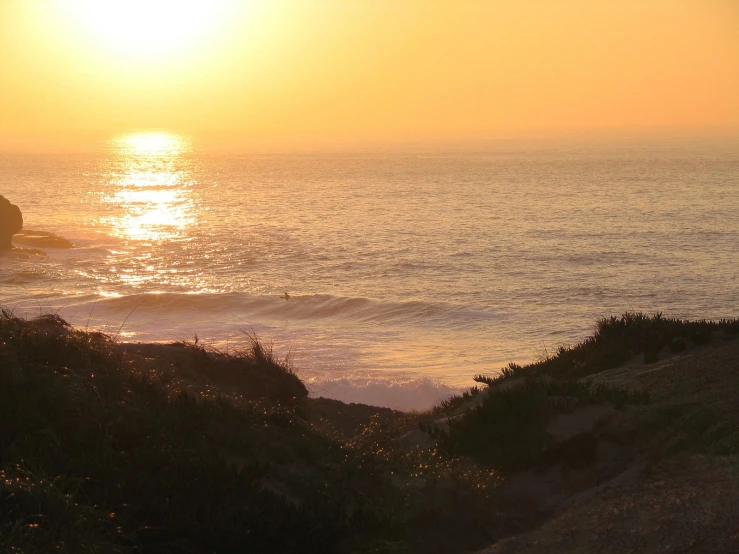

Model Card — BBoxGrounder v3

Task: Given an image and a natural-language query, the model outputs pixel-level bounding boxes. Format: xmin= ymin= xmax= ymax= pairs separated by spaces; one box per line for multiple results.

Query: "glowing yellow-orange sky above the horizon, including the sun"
xmin=0 ymin=0 xmax=739 ymax=149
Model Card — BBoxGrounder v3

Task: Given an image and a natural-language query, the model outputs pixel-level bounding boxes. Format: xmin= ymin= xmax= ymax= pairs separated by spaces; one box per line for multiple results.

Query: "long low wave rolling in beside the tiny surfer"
xmin=92 ymin=293 xmax=494 ymax=325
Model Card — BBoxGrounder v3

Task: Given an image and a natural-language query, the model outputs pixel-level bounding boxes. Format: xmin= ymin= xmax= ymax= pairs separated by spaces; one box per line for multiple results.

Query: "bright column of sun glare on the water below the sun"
xmin=91 ymin=133 xmax=204 ymax=296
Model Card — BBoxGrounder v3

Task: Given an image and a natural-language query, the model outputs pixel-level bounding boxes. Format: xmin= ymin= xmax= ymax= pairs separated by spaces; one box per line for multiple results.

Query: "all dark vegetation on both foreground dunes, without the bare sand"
xmin=0 ymin=311 xmax=739 ymax=553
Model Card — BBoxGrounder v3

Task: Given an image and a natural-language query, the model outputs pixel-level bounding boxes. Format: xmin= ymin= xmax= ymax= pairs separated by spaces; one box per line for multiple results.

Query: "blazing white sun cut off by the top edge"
xmin=61 ymin=0 xmax=229 ymax=59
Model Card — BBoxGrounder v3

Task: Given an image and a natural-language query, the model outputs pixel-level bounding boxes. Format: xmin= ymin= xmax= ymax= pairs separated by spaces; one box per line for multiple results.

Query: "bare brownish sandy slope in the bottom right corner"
xmin=480 ymin=341 xmax=739 ymax=554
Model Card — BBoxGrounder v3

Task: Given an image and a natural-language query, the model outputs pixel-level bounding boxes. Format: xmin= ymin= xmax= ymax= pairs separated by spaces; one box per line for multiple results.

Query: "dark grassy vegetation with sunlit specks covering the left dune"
xmin=0 ymin=312 xmax=502 ymax=553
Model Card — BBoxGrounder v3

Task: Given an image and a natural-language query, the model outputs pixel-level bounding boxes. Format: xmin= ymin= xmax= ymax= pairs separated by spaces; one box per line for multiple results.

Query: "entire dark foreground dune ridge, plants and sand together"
xmin=0 ymin=311 xmax=739 ymax=553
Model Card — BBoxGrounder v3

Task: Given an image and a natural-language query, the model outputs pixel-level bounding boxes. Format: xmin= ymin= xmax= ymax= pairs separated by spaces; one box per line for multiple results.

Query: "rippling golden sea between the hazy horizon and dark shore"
xmin=0 ymin=133 xmax=739 ymax=409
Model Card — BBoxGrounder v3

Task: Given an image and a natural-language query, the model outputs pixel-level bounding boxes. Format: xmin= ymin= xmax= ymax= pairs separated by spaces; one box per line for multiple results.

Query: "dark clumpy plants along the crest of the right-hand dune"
xmin=422 ymin=313 xmax=739 ymax=472
